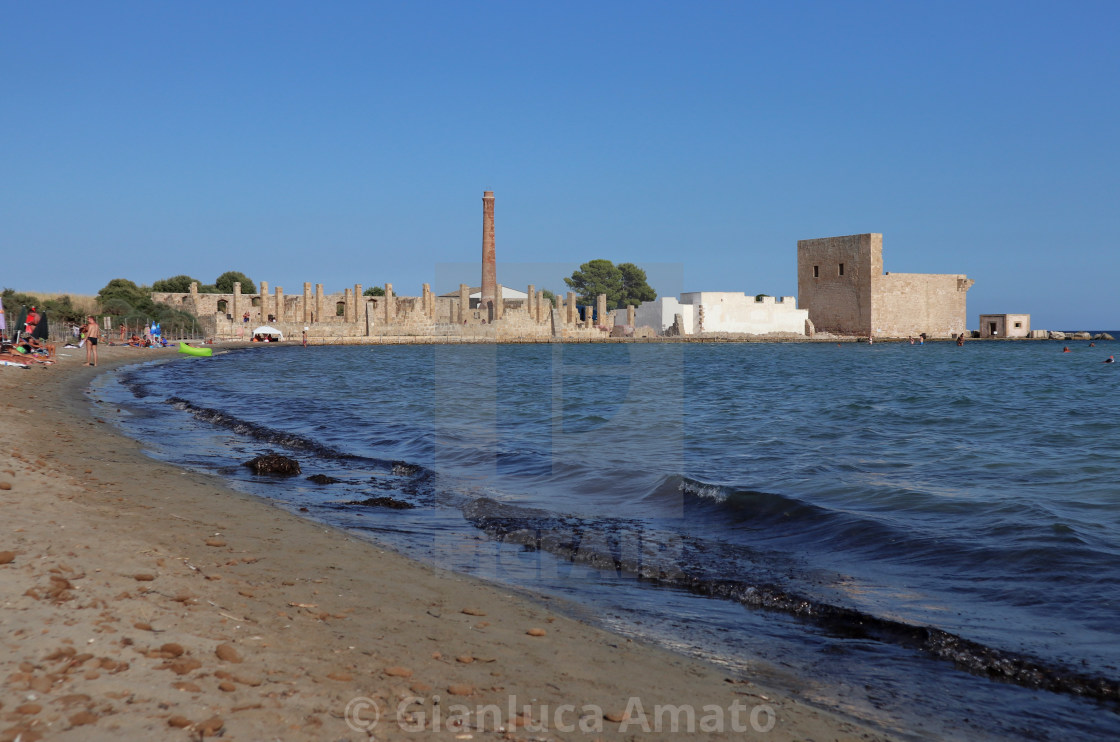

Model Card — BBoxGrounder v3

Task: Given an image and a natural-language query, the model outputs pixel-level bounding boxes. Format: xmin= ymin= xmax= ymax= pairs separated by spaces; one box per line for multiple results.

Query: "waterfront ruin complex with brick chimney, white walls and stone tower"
xmin=152 ymin=191 xmax=981 ymax=344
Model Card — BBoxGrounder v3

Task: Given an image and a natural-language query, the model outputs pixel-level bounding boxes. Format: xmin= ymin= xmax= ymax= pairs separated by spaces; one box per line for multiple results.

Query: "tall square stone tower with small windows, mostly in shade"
xmin=797 ymin=233 xmax=883 ymax=335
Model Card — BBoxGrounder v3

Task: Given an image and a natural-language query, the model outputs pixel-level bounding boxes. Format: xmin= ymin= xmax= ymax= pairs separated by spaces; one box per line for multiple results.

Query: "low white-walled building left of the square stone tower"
xmin=634 ymin=291 xmax=809 ymax=335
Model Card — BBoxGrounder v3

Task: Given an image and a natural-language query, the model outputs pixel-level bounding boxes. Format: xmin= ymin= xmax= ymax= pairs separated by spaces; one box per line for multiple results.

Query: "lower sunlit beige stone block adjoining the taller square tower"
xmin=871 ymin=273 xmax=972 ymax=337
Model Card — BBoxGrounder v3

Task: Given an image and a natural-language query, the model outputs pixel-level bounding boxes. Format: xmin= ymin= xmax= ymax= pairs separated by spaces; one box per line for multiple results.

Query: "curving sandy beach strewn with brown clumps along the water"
xmin=0 ymin=346 xmax=887 ymax=741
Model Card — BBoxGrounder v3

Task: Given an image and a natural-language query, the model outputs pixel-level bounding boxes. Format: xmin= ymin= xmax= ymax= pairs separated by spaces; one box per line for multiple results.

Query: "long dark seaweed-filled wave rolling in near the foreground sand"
xmin=463 ymin=498 xmax=1120 ymax=703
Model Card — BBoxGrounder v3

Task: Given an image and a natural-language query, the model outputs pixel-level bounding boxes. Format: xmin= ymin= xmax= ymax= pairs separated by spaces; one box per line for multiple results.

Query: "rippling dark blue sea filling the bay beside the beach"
xmin=92 ymin=342 xmax=1120 ymax=740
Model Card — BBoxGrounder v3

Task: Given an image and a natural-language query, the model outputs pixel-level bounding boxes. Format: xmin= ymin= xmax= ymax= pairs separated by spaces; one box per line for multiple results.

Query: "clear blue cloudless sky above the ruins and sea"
xmin=0 ymin=0 xmax=1120 ymax=328
